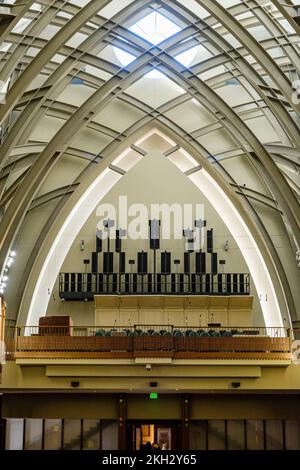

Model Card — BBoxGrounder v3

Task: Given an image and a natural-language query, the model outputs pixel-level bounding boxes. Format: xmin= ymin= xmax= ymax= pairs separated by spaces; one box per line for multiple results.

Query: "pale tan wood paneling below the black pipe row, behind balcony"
xmin=95 ymin=295 xmax=253 ymax=327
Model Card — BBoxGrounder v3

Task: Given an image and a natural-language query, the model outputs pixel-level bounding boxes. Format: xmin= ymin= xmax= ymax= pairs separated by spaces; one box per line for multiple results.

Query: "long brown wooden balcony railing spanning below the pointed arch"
xmin=3 ymin=325 xmax=291 ymax=360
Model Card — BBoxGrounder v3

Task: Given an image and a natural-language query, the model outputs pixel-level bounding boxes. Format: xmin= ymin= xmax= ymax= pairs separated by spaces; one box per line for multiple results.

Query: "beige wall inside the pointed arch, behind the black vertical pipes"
xmin=47 ymin=149 xmax=263 ymax=325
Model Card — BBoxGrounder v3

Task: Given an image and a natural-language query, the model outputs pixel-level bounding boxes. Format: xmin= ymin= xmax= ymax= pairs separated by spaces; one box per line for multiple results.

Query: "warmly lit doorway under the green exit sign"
xmin=127 ymin=420 xmax=181 ymax=451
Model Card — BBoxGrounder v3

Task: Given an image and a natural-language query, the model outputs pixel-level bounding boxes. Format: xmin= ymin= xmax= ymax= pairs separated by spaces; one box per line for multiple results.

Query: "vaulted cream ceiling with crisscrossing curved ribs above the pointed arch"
xmin=0 ymin=0 xmax=300 ymax=320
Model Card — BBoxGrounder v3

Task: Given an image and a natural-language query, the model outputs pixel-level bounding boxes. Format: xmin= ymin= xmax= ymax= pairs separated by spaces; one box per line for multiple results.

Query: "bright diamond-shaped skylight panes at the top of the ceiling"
xmin=114 ymin=11 xmax=196 ymax=78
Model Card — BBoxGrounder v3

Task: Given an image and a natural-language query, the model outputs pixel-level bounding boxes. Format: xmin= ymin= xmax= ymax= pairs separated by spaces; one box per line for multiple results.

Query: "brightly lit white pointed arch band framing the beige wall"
xmin=18 ymin=122 xmax=290 ymax=327
